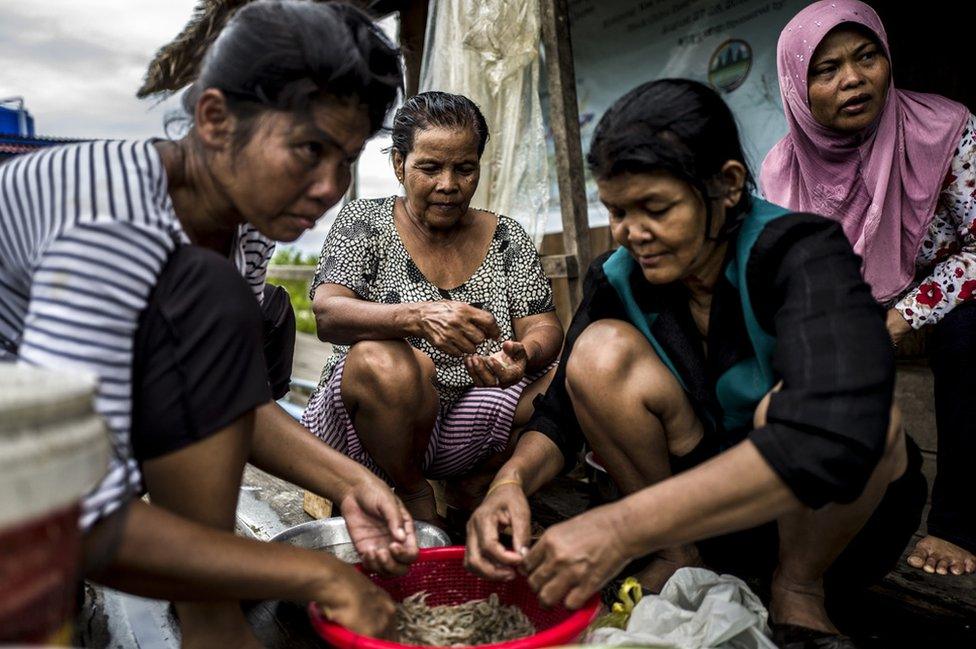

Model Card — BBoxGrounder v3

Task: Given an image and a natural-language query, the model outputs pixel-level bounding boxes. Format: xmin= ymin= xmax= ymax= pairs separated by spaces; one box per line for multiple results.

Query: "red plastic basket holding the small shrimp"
xmin=308 ymin=546 xmax=600 ymax=649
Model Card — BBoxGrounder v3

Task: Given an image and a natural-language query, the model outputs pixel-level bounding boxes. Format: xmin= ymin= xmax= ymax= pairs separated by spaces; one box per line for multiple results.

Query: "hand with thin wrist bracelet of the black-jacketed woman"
xmin=464 ymin=480 xmax=532 ymax=581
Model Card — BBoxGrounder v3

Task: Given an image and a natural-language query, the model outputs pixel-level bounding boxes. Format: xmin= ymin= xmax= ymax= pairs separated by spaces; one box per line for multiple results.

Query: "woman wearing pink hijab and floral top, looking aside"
xmin=760 ymin=0 xmax=976 ymax=575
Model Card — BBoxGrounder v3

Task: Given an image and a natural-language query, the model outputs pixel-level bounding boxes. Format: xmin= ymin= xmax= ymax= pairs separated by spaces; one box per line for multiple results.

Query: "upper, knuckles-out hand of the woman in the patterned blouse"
xmin=418 ymin=300 xmax=501 ymax=356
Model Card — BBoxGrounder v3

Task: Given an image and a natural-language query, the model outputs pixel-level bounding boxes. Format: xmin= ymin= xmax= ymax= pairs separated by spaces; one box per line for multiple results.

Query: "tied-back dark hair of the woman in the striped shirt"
xmin=183 ymin=0 xmax=403 ymax=142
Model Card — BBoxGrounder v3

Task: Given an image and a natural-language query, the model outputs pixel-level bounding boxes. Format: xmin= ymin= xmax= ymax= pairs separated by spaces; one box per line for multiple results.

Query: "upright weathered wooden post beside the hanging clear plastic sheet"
xmin=539 ymin=0 xmax=592 ymax=311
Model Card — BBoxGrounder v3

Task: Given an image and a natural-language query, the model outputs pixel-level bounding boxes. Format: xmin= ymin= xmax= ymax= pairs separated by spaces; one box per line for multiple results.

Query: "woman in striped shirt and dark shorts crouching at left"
xmin=0 ymin=0 xmax=416 ymax=646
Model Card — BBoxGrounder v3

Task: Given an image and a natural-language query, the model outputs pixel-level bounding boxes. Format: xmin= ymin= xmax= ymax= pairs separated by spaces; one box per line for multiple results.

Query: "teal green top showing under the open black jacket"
xmin=603 ymin=197 xmax=789 ymax=430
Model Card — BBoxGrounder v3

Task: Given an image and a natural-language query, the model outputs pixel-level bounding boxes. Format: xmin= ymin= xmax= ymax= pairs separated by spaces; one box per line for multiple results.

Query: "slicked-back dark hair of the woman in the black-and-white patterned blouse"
xmin=390 ymin=91 xmax=488 ymax=158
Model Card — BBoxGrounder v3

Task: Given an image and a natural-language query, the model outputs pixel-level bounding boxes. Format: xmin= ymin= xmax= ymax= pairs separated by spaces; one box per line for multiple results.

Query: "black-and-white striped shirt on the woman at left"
xmin=0 ymin=140 xmax=274 ymax=528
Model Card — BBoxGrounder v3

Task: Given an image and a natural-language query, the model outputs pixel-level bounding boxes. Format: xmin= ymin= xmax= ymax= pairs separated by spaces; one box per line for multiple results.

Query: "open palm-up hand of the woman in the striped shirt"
xmin=339 ymin=475 xmax=418 ymax=575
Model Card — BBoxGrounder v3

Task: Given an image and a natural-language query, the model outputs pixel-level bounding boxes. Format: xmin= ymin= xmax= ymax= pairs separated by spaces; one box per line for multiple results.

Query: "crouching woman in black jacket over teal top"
xmin=468 ymin=80 xmax=925 ymax=646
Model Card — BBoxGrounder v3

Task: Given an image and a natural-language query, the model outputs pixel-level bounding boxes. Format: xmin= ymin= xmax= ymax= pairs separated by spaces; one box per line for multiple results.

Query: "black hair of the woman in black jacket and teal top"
xmin=586 ymin=79 xmax=755 ymax=238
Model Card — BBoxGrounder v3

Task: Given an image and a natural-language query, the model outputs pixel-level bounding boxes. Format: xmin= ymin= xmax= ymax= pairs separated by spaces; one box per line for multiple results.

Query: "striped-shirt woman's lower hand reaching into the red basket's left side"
xmin=312 ymin=560 xmax=396 ymax=638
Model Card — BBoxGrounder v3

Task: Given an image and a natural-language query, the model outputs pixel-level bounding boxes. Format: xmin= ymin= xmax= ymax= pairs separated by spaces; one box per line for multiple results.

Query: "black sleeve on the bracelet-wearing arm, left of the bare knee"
xmin=525 ymin=252 xmax=625 ymax=472
